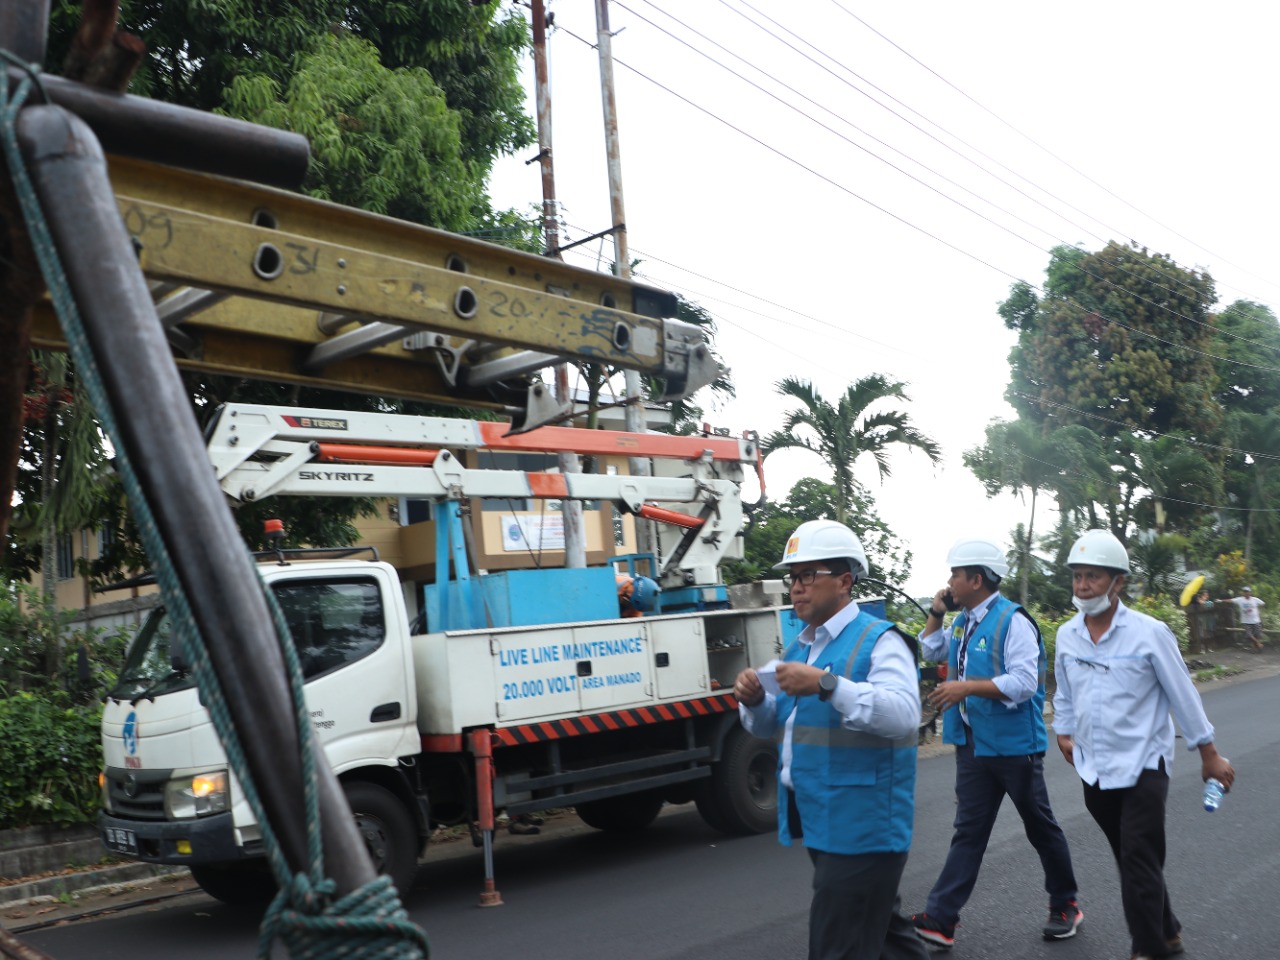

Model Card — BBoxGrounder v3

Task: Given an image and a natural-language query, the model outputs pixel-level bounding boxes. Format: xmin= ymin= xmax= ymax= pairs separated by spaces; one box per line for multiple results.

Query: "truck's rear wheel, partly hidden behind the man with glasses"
xmin=696 ymin=727 xmax=778 ymax=833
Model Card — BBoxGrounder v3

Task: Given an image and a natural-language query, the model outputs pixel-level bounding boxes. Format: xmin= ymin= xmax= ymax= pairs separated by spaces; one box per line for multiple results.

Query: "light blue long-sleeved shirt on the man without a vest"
xmin=1053 ymin=603 xmax=1213 ymax=790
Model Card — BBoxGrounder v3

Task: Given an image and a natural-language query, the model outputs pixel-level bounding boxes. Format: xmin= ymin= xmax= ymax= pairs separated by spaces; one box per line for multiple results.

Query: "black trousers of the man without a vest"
xmin=1084 ymin=760 xmax=1183 ymax=956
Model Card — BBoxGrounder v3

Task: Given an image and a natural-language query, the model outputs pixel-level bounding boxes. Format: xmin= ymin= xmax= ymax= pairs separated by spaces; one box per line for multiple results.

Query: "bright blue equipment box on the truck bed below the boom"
xmin=422 ymin=567 xmax=618 ymax=632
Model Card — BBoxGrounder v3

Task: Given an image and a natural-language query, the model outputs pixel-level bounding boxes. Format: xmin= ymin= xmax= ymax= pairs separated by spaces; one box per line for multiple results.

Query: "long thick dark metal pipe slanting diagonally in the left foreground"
xmin=18 ymin=106 xmax=374 ymax=893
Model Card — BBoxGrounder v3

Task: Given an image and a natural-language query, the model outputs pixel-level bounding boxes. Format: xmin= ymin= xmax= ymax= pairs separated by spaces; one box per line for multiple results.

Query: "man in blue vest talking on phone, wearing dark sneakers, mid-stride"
xmin=911 ymin=538 xmax=1084 ymax=948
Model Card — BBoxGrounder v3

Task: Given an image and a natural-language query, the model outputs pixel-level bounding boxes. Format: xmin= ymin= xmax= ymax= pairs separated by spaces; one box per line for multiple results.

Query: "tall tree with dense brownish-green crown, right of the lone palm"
xmin=998 ymin=243 xmax=1222 ymax=536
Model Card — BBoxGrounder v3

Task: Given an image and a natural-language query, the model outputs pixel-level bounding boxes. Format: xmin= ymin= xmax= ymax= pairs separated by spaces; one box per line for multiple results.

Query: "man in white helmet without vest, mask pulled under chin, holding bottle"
xmin=1053 ymin=530 xmax=1235 ymax=960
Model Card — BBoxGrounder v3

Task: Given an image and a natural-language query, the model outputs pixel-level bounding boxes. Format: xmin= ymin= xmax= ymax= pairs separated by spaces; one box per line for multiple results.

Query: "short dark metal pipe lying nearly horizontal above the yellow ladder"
xmin=8 ymin=67 xmax=311 ymax=189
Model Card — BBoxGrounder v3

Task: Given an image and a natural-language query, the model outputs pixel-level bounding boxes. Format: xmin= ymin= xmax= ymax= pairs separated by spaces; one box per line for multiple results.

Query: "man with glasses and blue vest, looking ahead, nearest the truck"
xmin=733 ymin=520 xmax=928 ymax=960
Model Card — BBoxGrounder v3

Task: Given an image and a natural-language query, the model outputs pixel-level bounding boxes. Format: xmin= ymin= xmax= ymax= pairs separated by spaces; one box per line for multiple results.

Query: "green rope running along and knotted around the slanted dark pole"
xmin=0 ymin=50 xmax=430 ymax=959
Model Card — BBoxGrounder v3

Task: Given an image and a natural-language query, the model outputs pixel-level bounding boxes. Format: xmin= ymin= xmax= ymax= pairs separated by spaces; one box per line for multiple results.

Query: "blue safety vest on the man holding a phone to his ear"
xmin=942 ymin=595 xmax=1048 ymax=756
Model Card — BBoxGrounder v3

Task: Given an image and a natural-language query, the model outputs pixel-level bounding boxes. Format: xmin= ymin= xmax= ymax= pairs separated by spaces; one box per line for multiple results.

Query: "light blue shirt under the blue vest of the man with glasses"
xmin=737 ymin=600 xmax=920 ymax=787
